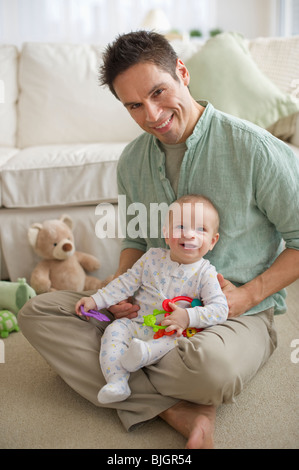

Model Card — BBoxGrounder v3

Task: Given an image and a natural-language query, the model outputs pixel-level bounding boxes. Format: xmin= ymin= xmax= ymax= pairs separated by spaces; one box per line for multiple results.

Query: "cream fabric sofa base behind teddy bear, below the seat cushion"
xmin=0 ymin=206 xmax=121 ymax=282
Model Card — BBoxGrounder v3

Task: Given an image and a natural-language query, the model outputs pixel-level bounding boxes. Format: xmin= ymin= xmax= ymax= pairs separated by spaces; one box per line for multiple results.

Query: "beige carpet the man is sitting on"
xmin=0 ymin=281 xmax=299 ymax=449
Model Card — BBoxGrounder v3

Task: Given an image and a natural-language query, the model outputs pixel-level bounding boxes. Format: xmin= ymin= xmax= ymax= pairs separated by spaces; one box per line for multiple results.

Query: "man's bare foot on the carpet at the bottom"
xmin=160 ymin=401 xmax=216 ymax=449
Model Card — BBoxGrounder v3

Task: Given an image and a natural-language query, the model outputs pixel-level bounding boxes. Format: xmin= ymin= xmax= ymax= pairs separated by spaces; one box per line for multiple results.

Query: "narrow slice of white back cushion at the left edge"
xmin=0 ymin=45 xmax=18 ymax=147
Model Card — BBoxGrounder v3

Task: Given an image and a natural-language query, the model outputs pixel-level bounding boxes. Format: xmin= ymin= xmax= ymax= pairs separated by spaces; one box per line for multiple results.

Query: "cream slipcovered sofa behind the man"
xmin=0 ymin=37 xmax=299 ymax=281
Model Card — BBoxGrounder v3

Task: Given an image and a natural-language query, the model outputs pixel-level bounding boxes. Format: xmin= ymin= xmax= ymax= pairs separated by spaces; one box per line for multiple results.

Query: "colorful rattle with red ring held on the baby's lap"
xmin=143 ymin=295 xmax=203 ymax=339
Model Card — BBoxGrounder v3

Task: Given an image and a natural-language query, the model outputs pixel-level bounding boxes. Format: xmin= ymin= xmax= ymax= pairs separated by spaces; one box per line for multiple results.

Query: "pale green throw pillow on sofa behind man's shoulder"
xmin=186 ymin=33 xmax=299 ymax=132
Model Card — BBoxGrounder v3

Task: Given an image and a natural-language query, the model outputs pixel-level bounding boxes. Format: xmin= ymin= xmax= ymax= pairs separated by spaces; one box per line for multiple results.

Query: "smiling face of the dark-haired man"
xmin=113 ymin=60 xmax=199 ymax=144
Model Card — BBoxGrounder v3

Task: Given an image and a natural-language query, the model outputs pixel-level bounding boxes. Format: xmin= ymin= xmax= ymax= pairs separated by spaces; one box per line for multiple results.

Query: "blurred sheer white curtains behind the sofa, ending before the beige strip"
xmin=0 ymin=0 xmax=215 ymax=45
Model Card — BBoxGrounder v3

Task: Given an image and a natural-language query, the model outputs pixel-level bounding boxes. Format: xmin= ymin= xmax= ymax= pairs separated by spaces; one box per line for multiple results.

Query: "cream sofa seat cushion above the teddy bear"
xmin=1 ymin=143 xmax=126 ymax=208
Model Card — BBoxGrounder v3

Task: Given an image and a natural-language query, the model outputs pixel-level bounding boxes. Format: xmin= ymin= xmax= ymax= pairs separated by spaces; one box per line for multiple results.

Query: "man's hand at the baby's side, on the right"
xmin=217 ymin=274 xmax=252 ymax=318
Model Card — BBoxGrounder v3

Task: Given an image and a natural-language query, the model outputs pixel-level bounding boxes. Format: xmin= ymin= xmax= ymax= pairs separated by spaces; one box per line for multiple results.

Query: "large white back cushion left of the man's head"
xmin=18 ymin=43 xmax=141 ymax=148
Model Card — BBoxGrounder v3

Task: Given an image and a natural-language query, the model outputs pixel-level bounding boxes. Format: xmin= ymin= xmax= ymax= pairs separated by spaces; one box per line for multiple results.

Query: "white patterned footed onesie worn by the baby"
xmin=92 ymin=248 xmax=228 ymax=403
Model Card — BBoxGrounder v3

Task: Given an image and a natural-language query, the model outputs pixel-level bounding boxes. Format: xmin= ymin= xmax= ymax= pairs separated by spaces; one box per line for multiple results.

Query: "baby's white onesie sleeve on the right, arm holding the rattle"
xmin=186 ymin=265 xmax=228 ymax=328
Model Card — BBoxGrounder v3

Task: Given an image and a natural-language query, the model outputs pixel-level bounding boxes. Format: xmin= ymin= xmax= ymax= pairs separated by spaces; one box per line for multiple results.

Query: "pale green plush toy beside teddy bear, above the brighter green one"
xmin=0 ymin=278 xmax=36 ymax=315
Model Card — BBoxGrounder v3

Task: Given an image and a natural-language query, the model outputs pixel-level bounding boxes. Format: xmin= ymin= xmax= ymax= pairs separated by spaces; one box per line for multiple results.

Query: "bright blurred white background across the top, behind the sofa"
xmin=0 ymin=0 xmax=291 ymax=46
